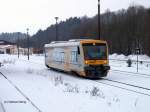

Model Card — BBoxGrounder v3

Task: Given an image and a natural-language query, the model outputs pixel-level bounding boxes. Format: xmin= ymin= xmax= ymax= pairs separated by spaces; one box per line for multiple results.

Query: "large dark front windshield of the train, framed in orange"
xmin=83 ymin=43 xmax=107 ymax=60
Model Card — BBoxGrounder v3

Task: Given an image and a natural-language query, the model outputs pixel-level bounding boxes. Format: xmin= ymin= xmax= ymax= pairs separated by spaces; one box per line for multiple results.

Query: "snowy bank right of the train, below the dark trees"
xmin=109 ymin=54 xmax=150 ymax=75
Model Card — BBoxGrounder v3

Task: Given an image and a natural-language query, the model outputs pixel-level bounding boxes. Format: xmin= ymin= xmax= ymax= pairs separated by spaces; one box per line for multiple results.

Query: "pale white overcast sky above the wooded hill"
xmin=0 ymin=0 xmax=150 ymax=35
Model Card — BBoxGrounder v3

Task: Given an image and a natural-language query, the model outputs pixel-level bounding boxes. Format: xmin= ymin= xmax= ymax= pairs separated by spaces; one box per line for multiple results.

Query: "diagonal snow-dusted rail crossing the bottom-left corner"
xmin=0 ymin=72 xmax=42 ymax=112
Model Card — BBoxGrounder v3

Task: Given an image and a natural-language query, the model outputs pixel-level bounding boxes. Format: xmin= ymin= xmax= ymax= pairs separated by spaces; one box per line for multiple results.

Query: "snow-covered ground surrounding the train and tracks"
xmin=0 ymin=54 xmax=150 ymax=112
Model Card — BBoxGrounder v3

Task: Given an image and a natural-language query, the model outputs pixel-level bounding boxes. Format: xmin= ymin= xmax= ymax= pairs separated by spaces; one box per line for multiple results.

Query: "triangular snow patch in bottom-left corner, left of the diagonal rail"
xmin=0 ymin=72 xmax=38 ymax=112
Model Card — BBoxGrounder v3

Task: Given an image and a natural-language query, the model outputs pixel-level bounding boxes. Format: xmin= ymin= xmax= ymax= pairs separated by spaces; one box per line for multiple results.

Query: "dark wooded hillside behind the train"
xmin=0 ymin=6 xmax=150 ymax=56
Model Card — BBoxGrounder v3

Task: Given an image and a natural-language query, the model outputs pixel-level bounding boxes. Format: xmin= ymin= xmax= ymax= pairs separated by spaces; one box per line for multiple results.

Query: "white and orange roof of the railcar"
xmin=45 ymin=39 xmax=106 ymax=47
